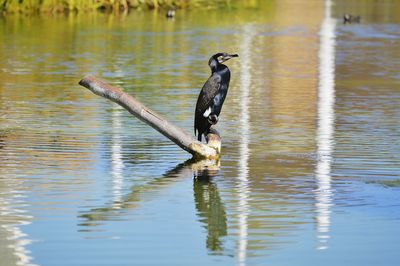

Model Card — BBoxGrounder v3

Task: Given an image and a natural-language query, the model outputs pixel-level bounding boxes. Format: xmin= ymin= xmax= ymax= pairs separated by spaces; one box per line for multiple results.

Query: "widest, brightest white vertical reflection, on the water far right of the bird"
xmin=315 ymin=0 xmax=335 ymax=249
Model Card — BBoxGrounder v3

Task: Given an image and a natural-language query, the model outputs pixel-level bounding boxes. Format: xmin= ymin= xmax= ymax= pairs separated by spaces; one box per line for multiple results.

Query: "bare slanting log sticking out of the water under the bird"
xmin=79 ymin=76 xmax=221 ymax=158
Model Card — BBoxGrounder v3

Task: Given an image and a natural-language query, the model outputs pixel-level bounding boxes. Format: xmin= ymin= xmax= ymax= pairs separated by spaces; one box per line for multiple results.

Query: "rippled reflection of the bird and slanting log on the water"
xmin=79 ymin=159 xmax=228 ymax=254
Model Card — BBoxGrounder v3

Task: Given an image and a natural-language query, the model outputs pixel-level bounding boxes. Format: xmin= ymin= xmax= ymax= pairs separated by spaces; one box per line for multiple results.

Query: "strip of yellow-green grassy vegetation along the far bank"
xmin=0 ymin=0 xmax=236 ymax=14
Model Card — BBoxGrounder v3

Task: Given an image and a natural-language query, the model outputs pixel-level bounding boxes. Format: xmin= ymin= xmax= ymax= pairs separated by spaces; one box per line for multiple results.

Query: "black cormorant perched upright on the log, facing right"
xmin=194 ymin=53 xmax=238 ymax=141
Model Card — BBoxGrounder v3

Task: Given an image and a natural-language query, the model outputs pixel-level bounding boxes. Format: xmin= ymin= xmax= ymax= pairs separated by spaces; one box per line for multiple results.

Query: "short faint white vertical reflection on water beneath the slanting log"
xmin=111 ymin=107 xmax=124 ymax=208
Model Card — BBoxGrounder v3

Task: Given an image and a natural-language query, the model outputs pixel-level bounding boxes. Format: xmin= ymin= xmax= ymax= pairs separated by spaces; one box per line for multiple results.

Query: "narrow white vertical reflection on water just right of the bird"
xmin=237 ymin=25 xmax=253 ymax=265
